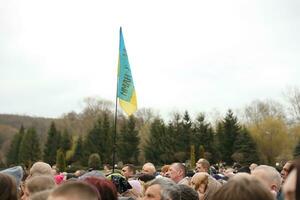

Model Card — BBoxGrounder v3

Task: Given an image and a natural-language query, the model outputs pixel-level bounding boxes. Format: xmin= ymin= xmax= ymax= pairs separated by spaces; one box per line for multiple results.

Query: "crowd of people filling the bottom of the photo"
xmin=0 ymin=158 xmax=300 ymax=200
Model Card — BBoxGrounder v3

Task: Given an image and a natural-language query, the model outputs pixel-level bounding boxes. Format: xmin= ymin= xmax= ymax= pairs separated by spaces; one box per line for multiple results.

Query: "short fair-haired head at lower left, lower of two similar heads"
xmin=21 ymin=176 xmax=55 ymax=200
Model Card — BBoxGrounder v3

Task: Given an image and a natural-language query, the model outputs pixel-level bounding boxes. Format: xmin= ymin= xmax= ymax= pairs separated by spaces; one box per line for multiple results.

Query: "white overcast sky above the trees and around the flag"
xmin=0 ymin=0 xmax=300 ymax=117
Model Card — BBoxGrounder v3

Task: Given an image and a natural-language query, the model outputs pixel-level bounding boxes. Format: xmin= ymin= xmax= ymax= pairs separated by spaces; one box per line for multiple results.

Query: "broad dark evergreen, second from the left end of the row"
xmin=19 ymin=128 xmax=41 ymax=167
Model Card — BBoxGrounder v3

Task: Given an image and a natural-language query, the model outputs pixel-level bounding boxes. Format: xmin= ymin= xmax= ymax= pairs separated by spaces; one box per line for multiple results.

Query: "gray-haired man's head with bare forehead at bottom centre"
xmin=143 ymin=178 xmax=181 ymax=200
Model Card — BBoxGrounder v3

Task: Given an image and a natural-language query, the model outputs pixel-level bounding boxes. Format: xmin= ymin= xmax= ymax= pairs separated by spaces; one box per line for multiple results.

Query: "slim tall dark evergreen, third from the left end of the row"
xmin=44 ymin=122 xmax=61 ymax=165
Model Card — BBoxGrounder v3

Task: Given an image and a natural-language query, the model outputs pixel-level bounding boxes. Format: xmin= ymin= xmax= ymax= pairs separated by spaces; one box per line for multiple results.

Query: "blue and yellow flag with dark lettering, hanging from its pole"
xmin=117 ymin=28 xmax=137 ymax=115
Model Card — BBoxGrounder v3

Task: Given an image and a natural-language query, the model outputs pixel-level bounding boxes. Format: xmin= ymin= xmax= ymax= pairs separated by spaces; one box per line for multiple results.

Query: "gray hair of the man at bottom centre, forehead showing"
xmin=149 ymin=178 xmax=181 ymax=200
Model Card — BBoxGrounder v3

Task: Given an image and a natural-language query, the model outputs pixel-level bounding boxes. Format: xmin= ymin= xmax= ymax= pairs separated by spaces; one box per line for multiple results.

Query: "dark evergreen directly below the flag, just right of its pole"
xmin=118 ymin=115 xmax=139 ymax=164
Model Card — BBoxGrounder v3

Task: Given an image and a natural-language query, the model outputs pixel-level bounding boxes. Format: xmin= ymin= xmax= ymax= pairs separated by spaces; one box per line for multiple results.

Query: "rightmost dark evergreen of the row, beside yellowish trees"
xmin=232 ymin=127 xmax=259 ymax=165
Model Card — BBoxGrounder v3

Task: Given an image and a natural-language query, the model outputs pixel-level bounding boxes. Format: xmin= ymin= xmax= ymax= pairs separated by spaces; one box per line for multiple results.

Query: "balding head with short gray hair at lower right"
xmin=251 ymin=165 xmax=282 ymax=196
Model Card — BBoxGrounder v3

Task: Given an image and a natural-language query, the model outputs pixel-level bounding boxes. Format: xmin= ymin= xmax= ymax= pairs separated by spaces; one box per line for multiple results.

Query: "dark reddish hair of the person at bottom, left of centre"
xmin=84 ymin=177 xmax=118 ymax=200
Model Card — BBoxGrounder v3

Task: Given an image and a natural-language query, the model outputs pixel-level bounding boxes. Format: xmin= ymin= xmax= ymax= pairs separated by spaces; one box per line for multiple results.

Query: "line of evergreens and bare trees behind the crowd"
xmin=5 ymin=87 xmax=300 ymax=169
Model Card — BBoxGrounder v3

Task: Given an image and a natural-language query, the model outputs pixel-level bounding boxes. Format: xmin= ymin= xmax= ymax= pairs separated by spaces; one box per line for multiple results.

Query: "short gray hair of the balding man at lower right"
xmin=253 ymin=165 xmax=282 ymax=192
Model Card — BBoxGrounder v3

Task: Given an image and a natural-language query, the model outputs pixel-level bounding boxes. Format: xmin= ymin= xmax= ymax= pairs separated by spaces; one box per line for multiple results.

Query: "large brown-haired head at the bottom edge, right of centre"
xmin=211 ymin=173 xmax=274 ymax=200
